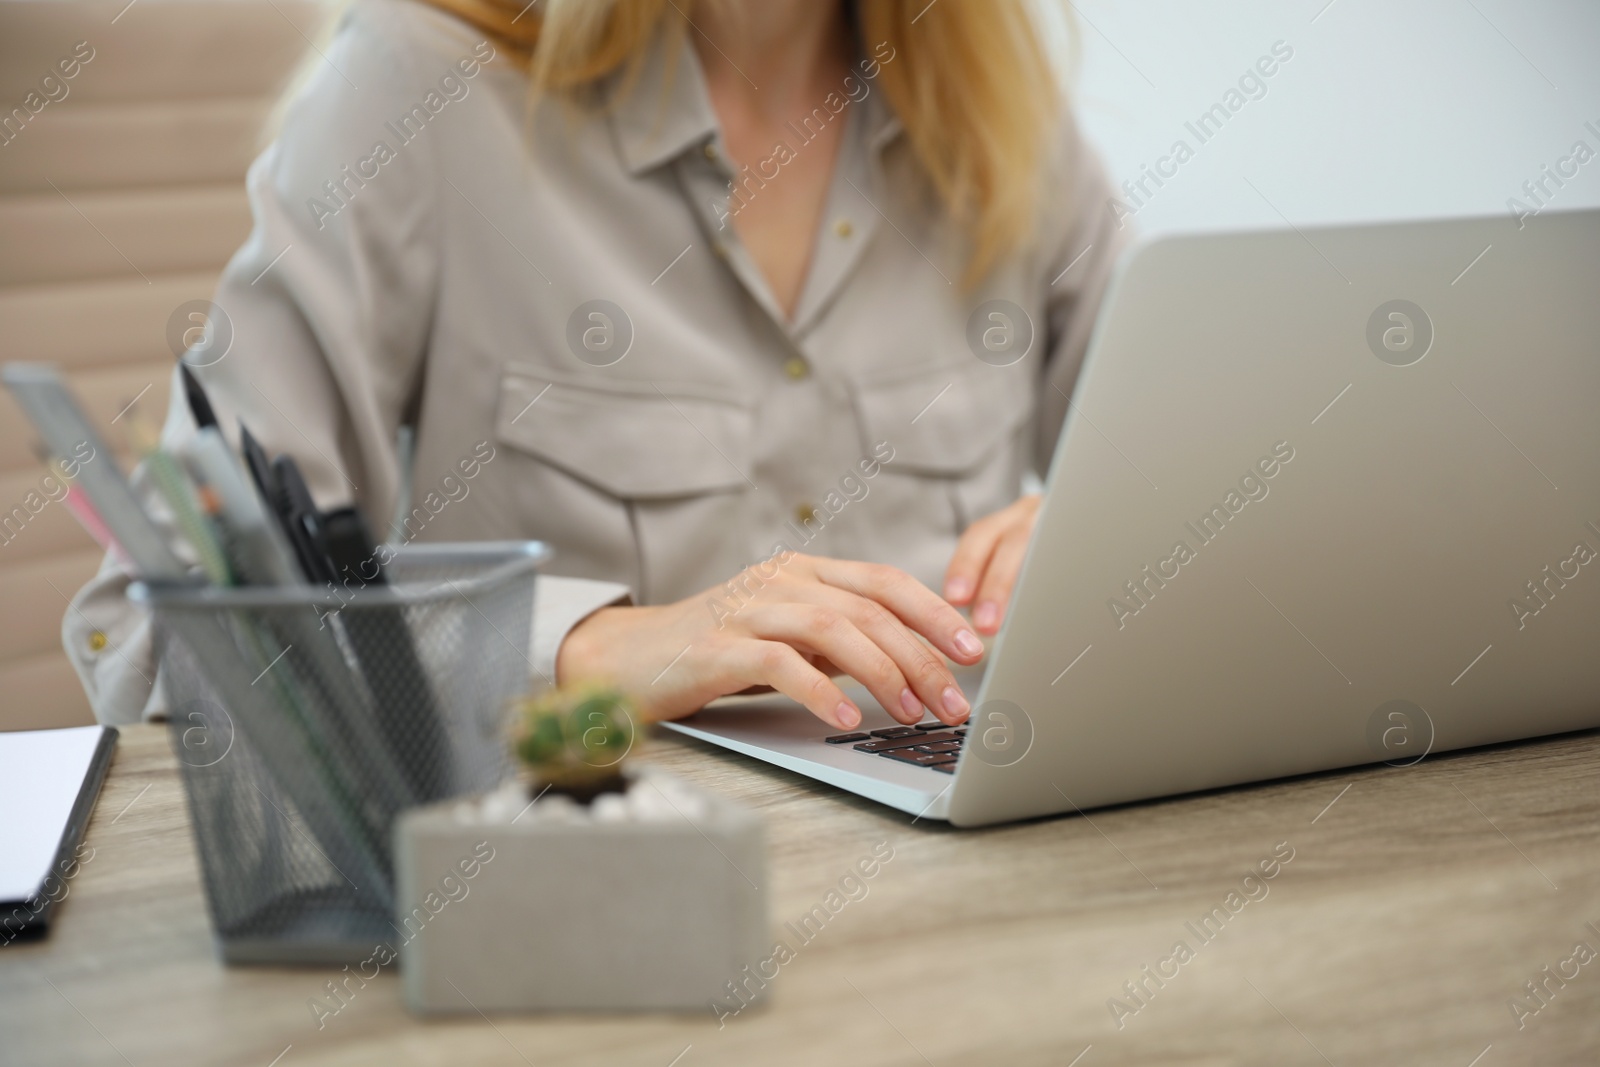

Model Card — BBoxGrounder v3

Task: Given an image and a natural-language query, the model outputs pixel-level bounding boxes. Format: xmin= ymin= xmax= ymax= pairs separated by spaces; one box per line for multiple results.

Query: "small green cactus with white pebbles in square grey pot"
xmin=395 ymin=685 xmax=771 ymax=1014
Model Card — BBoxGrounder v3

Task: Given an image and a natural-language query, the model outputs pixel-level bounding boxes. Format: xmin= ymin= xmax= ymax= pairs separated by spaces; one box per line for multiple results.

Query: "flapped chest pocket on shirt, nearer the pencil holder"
xmin=494 ymin=366 xmax=754 ymax=603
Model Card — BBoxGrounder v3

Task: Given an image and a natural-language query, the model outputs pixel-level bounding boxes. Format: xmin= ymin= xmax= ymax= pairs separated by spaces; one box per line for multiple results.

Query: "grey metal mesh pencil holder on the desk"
xmin=128 ymin=542 xmax=547 ymax=965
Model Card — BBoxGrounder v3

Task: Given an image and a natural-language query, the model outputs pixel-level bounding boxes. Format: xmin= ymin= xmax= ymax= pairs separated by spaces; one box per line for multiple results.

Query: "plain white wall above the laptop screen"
xmin=1072 ymin=0 xmax=1600 ymax=232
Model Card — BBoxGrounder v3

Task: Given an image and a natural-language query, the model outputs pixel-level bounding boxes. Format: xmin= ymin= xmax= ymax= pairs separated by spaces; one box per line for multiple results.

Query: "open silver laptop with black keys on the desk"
xmin=666 ymin=210 xmax=1600 ymax=827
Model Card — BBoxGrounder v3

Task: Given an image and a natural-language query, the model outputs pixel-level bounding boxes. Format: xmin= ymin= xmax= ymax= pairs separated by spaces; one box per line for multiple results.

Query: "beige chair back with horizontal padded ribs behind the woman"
xmin=0 ymin=0 xmax=326 ymax=729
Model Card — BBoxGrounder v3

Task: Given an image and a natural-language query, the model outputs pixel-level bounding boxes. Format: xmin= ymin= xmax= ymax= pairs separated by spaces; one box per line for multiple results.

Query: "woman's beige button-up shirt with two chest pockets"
xmin=64 ymin=0 xmax=1122 ymax=721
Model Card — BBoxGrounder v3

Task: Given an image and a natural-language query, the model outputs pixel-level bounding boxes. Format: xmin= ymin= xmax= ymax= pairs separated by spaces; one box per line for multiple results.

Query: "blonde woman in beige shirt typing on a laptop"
xmin=64 ymin=0 xmax=1120 ymax=729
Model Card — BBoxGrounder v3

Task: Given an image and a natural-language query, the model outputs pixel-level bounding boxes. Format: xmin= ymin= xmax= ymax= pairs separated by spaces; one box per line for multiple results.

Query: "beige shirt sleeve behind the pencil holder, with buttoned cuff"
xmin=62 ymin=5 xmax=627 ymax=723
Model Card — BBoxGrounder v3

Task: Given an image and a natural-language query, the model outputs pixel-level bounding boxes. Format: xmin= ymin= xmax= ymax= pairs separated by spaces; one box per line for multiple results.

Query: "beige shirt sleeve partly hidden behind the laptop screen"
xmin=1034 ymin=113 xmax=1134 ymax=474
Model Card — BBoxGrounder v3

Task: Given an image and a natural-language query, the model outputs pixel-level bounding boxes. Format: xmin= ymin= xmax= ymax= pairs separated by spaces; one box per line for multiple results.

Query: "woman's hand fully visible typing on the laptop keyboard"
xmin=555 ymin=552 xmax=984 ymax=729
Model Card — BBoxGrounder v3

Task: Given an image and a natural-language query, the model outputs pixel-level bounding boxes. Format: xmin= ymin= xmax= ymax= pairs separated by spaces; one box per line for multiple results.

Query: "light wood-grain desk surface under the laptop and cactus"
xmin=9 ymin=726 xmax=1600 ymax=1067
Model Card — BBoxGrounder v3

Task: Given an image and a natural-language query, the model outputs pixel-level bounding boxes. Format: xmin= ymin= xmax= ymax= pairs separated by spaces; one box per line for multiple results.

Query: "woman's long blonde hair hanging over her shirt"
xmin=427 ymin=0 xmax=1062 ymax=286
